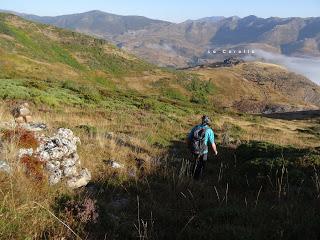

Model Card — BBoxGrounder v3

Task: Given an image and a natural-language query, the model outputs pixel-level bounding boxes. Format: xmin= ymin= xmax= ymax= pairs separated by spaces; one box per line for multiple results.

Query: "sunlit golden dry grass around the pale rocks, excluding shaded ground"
xmin=0 ymin=101 xmax=316 ymax=239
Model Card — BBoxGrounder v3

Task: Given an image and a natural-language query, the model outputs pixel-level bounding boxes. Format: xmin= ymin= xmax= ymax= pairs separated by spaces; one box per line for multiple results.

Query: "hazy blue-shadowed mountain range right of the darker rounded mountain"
xmin=115 ymin=16 xmax=320 ymax=66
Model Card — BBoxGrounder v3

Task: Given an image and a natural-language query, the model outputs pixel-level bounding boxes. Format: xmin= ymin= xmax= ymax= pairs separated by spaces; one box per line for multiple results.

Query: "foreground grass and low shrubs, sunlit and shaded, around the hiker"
xmin=0 ymin=99 xmax=320 ymax=239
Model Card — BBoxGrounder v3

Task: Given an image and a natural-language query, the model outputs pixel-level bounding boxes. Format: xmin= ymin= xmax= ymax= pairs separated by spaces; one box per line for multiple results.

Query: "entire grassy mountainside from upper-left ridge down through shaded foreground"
xmin=0 ymin=15 xmax=320 ymax=239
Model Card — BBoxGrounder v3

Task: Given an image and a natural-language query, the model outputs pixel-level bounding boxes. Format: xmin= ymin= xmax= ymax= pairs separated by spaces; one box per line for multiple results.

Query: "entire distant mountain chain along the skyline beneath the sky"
xmin=0 ymin=11 xmax=320 ymax=66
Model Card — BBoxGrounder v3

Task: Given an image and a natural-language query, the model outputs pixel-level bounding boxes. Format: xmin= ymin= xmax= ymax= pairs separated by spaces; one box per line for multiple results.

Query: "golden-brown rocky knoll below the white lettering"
xmin=191 ymin=61 xmax=320 ymax=113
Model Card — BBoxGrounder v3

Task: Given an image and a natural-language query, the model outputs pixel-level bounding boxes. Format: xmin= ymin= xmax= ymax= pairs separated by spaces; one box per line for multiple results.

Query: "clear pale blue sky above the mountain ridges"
xmin=0 ymin=0 xmax=320 ymax=22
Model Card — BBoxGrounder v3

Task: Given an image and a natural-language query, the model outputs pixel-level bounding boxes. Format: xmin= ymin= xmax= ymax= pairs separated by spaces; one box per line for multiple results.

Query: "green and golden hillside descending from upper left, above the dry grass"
xmin=0 ymin=14 xmax=218 ymax=110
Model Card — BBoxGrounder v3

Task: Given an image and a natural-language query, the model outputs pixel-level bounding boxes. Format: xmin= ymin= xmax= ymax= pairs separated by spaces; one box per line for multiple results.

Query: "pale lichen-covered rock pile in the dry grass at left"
xmin=0 ymin=124 xmax=91 ymax=188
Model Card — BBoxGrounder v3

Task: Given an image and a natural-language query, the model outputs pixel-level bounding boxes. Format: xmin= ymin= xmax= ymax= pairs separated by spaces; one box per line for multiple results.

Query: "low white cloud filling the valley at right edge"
xmin=249 ymin=50 xmax=320 ymax=85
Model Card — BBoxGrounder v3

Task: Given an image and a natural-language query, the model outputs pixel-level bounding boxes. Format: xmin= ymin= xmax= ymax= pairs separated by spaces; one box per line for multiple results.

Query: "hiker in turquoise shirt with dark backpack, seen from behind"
xmin=188 ymin=116 xmax=218 ymax=180
